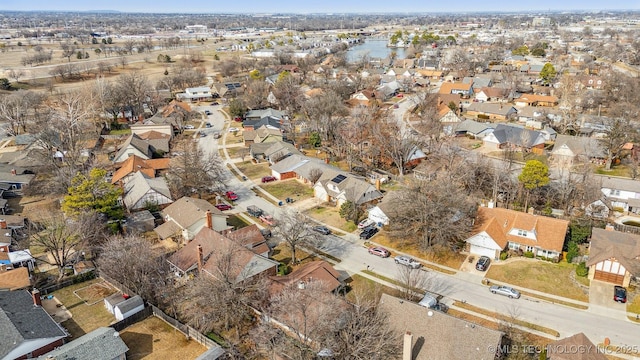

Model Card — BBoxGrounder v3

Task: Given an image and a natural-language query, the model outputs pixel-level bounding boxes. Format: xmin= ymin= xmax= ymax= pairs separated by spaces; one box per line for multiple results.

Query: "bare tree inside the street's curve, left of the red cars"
xmin=168 ymin=138 xmax=226 ymax=197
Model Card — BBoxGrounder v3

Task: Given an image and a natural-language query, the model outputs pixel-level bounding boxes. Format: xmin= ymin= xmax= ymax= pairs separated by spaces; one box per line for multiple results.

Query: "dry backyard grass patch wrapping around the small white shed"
xmin=53 ymin=279 xmax=115 ymax=338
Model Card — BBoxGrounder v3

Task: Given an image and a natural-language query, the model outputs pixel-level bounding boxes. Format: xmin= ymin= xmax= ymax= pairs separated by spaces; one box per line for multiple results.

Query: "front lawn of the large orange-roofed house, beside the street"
xmin=486 ymin=260 xmax=589 ymax=301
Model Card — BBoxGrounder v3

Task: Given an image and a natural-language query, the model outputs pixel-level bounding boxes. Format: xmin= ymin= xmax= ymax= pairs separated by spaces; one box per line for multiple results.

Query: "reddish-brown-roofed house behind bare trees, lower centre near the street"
xmin=269 ymin=260 xmax=344 ymax=294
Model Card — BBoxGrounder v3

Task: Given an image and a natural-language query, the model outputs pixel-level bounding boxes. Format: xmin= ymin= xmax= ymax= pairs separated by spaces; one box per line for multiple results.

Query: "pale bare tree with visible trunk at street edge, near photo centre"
xmin=273 ymin=209 xmax=316 ymax=264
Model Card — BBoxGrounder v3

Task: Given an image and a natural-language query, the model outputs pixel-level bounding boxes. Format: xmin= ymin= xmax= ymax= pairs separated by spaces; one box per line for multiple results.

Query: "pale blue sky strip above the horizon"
xmin=0 ymin=0 xmax=640 ymax=14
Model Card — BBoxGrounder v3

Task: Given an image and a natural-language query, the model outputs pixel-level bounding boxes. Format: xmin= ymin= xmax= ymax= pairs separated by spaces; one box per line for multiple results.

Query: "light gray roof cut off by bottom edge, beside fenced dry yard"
xmin=40 ymin=327 xmax=129 ymax=360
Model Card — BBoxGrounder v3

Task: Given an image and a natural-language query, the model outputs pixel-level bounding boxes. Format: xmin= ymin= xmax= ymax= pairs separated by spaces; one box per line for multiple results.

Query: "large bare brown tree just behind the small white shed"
xmin=97 ymin=235 xmax=170 ymax=302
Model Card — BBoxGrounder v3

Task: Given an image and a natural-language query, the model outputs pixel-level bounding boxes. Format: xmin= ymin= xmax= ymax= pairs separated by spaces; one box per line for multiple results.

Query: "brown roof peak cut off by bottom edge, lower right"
xmin=546 ymin=333 xmax=608 ymax=360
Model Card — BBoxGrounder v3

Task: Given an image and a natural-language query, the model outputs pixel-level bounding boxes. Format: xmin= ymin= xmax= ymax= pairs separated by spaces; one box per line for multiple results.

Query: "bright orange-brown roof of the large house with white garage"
xmin=473 ymin=207 xmax=569 ymax=252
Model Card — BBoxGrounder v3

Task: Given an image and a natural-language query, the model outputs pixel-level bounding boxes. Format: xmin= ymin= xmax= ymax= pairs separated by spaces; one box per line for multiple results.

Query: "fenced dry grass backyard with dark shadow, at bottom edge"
xmin=120 ymin=316 xmax=207 ymax=360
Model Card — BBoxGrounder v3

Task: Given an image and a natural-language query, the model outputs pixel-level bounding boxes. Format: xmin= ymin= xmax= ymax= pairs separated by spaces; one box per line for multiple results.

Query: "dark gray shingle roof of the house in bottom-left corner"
xmin=0 ymin=290 xmax=67 ymax=358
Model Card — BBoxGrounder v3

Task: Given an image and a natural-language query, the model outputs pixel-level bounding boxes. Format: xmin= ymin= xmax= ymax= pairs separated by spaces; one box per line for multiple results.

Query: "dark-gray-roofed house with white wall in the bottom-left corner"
xmin=0 ymin=290 xmax=68 ymax=360
